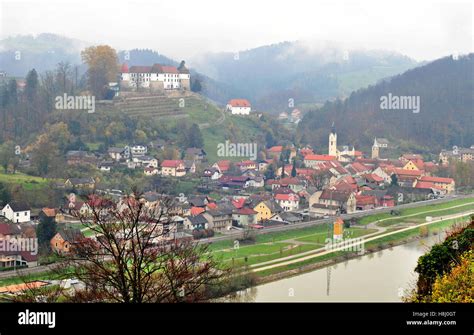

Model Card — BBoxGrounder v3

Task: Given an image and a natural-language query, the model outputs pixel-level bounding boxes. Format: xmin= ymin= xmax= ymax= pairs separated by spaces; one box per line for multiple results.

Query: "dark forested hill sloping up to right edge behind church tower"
xmin=298 ymin=54 xmax=474 ymax=152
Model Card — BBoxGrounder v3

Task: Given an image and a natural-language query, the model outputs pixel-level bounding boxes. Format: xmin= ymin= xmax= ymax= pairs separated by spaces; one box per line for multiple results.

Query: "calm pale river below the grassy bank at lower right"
xmin=235 ymin=235 xmax=443 ymax=302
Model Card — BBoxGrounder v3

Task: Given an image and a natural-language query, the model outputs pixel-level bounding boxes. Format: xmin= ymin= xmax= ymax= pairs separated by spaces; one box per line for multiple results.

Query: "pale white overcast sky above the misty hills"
xmin=0 ymin=0 xmax=474 ymax=60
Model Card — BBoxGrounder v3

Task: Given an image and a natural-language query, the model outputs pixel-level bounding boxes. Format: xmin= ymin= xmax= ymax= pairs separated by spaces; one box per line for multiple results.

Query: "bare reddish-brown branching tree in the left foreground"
xmin=61 ymin=195 xmax=230 ymax=303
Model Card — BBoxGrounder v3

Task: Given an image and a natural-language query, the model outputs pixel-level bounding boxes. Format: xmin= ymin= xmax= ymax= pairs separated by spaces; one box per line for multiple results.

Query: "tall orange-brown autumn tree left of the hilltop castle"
xmin=81 ymin=45 xmax=119 ymax=99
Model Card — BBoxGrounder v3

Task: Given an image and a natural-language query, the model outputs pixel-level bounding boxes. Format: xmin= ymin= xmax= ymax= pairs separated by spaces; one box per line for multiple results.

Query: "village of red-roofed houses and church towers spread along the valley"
xmin=0 ymin=113 xmax=468 ymax=270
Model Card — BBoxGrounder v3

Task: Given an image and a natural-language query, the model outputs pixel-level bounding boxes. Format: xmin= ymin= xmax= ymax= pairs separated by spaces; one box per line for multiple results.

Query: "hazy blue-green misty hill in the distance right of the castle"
xmin=193 ymin=42 xmax=417 ymax=112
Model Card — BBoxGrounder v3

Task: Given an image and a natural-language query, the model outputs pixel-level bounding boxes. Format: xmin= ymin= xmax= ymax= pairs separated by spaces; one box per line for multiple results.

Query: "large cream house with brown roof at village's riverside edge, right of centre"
xmin=309 ymin=189 xmax=356 ymax=215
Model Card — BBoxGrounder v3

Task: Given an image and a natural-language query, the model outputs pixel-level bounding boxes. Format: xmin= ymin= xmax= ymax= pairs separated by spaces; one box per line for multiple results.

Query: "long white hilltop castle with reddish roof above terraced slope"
xmin=120 ymin=61 xmax=191 ymax=90
